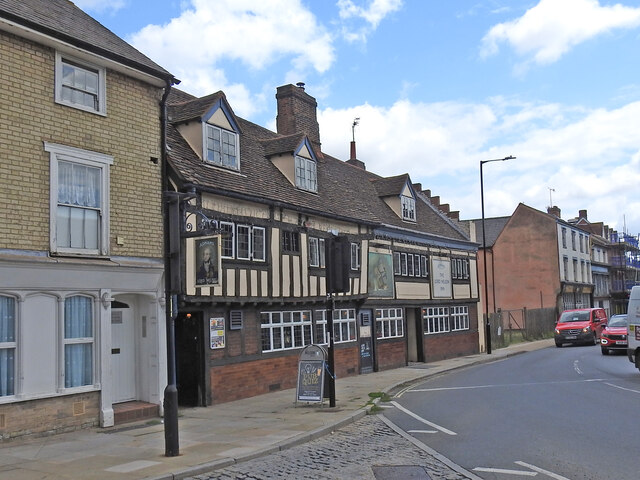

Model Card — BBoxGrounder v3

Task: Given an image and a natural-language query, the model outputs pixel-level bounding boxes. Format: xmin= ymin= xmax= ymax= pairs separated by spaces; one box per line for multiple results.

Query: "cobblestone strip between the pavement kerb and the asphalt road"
xmin=191 ymin=415 xmax=468 ymax=480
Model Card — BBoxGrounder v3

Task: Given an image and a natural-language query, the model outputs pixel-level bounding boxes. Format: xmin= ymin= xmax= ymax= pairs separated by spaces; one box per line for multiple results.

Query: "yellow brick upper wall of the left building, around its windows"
xmin=0 ymin=33 xmax=162 ymax=258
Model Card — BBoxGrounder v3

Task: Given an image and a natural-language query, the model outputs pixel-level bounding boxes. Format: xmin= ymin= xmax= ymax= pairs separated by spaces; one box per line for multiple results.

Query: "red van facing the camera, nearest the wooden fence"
xmin=554 ymin=308 xmax=607 ymax=347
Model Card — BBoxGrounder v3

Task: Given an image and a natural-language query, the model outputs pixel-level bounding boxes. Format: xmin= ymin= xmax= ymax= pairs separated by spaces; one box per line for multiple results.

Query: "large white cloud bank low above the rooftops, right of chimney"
xmin=318 ymin=98 xmax=640 ymax=234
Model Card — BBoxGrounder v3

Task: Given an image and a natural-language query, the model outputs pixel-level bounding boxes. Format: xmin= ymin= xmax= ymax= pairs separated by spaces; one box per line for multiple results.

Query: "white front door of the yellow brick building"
xmin=111 ymin=308 xmax=136 ymax=403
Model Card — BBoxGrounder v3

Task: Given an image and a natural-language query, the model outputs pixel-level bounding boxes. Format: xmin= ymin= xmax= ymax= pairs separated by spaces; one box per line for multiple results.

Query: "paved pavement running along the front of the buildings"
xmin=0 ymin=339 xmax=553 ymax=480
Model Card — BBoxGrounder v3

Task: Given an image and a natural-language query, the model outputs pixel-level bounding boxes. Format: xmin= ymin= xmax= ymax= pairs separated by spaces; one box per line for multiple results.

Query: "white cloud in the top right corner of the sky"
xmin=481 ymin=0 xmax=640 ymax=68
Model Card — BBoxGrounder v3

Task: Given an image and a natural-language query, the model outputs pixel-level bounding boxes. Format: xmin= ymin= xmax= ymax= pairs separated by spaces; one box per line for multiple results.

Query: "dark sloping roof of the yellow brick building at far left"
xmin=0 ymin=0 xmax=173 ymax=79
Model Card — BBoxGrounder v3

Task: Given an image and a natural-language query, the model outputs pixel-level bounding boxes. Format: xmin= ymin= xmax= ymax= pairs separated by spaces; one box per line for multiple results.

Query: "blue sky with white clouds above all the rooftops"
xmin=79 ymin=0 xmax=640 ymax=235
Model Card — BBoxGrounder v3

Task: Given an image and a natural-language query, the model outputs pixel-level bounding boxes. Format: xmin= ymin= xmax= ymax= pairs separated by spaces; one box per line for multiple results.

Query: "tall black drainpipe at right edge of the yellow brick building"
xmin=160 ymin=79 xmax=180 ymax=457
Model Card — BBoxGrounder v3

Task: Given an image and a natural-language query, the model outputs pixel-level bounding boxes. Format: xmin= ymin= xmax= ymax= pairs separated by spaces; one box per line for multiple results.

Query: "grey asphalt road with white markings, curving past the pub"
xmin=384 ymin=345 xmax=640 ymax=480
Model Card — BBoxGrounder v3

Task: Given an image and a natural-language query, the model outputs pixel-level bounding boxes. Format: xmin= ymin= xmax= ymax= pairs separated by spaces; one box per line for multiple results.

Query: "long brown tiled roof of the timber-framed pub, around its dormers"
xmin=167 ymin=91 xmax=468 ymax=241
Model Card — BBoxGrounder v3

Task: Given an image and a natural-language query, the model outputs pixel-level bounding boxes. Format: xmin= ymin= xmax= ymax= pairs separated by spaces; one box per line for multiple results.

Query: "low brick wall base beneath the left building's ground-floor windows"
xmin=0 ymin=392 xmax=100 ymax=440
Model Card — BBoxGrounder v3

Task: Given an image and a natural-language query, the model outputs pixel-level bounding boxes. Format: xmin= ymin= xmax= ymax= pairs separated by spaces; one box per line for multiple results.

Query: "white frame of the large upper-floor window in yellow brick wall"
xmin=44 ymin=142 xmax=113 ymax=255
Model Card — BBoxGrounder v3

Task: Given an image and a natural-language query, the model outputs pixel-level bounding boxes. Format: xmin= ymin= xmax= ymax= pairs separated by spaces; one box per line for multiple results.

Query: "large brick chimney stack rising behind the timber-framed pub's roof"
xmin=276 ymin=82 xmax=321 ymax=154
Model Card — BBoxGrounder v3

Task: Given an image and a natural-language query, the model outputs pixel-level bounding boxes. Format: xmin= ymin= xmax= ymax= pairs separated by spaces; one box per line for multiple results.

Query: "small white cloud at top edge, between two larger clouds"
xmin=337 ymin=0 xmax=402 ymax=42
